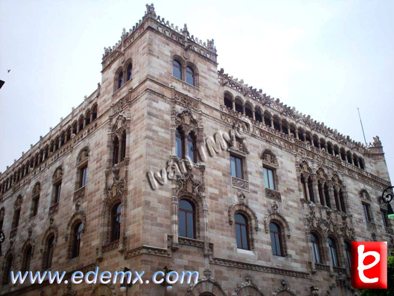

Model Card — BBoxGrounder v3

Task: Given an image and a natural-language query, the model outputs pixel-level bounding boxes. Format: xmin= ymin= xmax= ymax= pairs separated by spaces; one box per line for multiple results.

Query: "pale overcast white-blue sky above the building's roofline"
xmin=0 ymin=0 xmax=394 ymax=183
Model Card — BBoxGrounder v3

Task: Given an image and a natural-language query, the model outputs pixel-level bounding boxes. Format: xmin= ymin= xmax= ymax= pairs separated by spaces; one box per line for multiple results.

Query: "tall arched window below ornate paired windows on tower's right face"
xmin=178 ymin=199 xmax=196 ymax=238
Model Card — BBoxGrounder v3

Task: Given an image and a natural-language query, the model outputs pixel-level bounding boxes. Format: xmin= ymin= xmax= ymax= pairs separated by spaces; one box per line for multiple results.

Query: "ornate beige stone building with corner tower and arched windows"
xmin=0 ymin=5 xmax=393 ymax=296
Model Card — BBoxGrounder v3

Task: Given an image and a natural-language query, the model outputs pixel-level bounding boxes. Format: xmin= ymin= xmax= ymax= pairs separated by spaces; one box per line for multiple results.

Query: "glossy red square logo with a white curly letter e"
xmin=352 ymin=242 xmax=387 ymax=289
